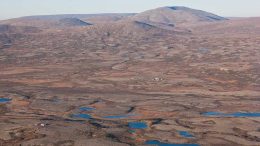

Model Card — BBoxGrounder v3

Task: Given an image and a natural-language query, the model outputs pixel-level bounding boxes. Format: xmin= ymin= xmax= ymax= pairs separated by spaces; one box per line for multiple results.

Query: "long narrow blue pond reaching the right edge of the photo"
xmin=202 ymin=112 xmax=260 ymax=117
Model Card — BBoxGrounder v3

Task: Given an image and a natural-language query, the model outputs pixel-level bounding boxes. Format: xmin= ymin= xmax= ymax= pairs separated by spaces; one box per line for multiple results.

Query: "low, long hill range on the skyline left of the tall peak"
xmin=0 ymin=14 xmax=134 ymax=28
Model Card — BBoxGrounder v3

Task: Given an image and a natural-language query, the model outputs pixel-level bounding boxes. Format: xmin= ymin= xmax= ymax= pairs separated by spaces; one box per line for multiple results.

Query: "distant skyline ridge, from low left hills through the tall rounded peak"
xmin=0 ymin=6 xmax=228 ymax=27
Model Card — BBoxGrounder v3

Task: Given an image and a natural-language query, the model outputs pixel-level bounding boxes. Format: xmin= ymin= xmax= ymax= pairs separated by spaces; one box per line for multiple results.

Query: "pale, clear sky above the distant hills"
xmin=0 ymin=0 xmax=260 ymax=20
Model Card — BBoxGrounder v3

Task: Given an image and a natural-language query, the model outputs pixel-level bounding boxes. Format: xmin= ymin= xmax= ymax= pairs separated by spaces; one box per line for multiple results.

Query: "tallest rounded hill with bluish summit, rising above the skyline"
xmin=131 ymin=7 xmax=228 ymax=27
